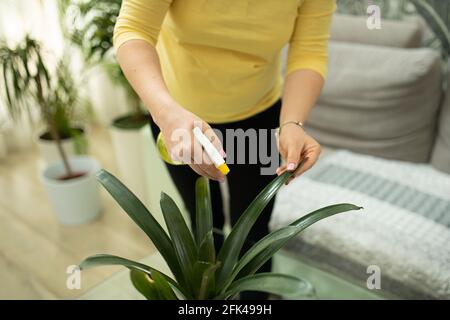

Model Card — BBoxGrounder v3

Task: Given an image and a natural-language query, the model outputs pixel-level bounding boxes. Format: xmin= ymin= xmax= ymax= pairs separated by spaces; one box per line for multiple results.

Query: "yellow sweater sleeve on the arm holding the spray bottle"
xmin=114 ymin=0 xmax=172 ymax=50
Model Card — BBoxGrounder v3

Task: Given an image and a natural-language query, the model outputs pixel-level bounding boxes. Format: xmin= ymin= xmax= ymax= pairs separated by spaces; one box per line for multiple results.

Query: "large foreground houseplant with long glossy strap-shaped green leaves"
xmin=80 ymin=170 xmax=360 ymax=300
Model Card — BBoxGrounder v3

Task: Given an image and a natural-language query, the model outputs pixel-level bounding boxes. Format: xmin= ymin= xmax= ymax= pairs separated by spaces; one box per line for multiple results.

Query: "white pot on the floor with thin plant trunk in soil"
xmin=41 ymin=156 xmax=101 ymax=226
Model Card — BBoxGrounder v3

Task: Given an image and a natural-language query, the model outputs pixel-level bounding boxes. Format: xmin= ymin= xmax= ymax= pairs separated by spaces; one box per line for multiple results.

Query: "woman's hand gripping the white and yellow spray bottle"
xmin=155 ymin=106 xmax=225 ymax=182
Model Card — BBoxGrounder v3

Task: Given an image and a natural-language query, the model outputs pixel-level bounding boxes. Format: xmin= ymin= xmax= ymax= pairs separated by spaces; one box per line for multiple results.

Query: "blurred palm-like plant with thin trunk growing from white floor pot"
xmin=0 ymin=35 xmax=83 ymax=177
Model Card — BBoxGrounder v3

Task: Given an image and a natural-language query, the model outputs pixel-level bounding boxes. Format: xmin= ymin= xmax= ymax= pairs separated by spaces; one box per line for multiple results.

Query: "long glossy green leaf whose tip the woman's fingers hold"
xmin=217 ymin=170 xmax=294 ymax=288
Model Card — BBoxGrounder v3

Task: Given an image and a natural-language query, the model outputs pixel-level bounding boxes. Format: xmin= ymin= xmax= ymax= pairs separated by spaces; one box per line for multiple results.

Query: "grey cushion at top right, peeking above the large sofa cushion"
xmin=331 ymin=14 xmax=425 ymax=48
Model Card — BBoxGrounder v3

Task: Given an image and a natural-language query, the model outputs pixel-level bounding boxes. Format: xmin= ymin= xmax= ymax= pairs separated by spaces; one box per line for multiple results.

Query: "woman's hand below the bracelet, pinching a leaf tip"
xmin=276 ymin=124 xmax=320 ymax=184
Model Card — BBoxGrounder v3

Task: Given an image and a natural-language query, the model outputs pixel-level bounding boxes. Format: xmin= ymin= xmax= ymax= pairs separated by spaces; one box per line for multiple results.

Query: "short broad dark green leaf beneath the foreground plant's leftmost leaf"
xmin=130 ymin=270 xmax=178 ymax=300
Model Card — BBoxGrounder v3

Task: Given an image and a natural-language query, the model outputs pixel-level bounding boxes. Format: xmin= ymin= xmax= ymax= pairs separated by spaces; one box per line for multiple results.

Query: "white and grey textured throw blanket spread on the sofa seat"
xmin=271 ymin=151 xmax=450 ymax=299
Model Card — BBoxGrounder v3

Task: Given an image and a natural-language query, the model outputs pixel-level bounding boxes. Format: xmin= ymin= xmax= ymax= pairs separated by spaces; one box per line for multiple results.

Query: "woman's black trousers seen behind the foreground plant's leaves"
xmin=151 ymin=101 xmax=281 ymax=299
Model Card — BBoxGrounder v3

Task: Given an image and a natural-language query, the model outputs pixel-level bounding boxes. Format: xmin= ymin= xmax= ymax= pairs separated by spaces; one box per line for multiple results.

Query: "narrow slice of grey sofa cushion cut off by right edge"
xmin=431 ymin=74 xmax=450 ymax=174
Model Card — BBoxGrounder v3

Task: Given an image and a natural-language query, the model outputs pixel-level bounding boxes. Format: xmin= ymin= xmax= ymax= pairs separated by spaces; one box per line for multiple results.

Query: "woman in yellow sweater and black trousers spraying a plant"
xmin=114 ymin=0 xmax=335 ymax=298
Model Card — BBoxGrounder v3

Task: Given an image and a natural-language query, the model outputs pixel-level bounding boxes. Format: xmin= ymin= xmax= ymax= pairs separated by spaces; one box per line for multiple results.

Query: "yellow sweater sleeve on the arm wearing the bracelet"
xmin=286 ymin=0 xmax=336 ymax=78
